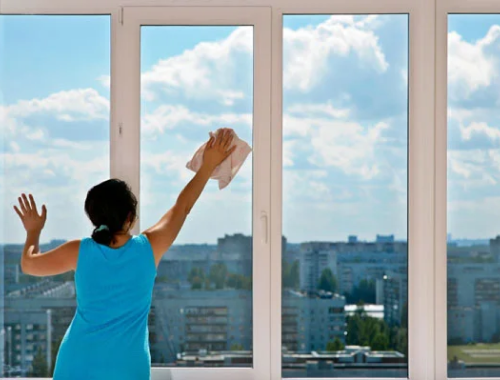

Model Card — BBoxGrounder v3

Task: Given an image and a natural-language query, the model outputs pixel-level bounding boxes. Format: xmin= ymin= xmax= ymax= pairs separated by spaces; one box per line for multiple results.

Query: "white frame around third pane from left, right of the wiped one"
xmin=271 ymin=0 xmax=435 ymax=380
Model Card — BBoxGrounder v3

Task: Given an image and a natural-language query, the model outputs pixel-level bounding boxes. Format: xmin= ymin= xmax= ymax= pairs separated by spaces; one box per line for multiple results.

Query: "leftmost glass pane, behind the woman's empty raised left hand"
xmin=0 ymin=15 xmax=110 ymax=377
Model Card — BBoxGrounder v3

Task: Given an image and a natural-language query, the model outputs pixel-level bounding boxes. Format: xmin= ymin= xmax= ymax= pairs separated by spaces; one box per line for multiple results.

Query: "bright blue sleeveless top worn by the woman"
xmin=54 ymin=235 xmax=157 ymax=380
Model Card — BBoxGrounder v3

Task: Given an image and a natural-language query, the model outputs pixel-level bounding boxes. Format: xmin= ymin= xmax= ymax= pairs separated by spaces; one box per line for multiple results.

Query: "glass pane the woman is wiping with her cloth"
xmin=141 ymin=26 xmax=253 ymax=367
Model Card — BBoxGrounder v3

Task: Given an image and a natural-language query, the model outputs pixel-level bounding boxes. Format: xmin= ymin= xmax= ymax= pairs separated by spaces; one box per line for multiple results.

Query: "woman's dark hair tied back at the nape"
xmin=85 ymin=179 xmax=137 ymax=246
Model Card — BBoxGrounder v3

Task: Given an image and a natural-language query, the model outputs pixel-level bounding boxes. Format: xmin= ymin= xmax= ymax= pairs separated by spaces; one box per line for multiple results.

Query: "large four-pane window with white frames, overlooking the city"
xmin=0 ymin=0 xmax=468 ymax=380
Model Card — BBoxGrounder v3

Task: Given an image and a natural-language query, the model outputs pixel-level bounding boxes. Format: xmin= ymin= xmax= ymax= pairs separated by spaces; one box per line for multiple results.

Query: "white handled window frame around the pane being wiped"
xmin=117 ymin=7 xmax=271 ymax=380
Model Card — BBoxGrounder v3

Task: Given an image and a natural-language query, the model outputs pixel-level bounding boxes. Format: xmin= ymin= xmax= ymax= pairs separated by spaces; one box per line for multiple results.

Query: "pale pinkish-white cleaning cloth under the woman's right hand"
xmin=186 ymin=131 xmax=252 ymax=190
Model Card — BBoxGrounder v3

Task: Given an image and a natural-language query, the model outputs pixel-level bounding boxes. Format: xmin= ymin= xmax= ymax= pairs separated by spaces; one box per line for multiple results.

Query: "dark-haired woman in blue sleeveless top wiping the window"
xmin=14 ymin=129 xmax=235 ymax=380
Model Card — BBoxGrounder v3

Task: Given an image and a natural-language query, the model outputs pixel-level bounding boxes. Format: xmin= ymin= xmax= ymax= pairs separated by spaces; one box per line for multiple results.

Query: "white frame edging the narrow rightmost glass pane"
xmin=434 ymin=0 xmax=500 ymax=380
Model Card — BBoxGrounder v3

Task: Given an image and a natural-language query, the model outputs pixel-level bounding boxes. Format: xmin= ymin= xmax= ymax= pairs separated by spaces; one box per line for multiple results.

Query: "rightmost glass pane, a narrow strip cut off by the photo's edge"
xmin=447 ymin=14 xmax=500 ymax=378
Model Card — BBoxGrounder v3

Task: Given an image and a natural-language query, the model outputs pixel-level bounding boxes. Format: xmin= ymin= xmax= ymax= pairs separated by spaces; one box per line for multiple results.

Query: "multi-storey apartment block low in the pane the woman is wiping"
xmin=151 ymin=284 xmax=253 ymax=363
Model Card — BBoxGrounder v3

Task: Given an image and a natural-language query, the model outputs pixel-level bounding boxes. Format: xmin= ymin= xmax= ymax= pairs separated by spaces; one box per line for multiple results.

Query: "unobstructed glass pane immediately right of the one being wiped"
xmin=282 ymin=15 xmax=408 ymax=378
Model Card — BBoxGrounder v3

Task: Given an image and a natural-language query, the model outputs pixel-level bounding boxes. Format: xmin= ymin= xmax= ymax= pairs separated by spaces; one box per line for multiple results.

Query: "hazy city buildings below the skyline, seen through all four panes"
xmin=0 ymin=234 xmax=500 ymax=377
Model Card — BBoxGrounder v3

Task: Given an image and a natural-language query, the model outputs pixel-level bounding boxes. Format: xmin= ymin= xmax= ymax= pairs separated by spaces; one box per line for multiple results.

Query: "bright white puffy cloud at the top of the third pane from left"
xmin=283 ymin=16 xmax=389 ymax=91
